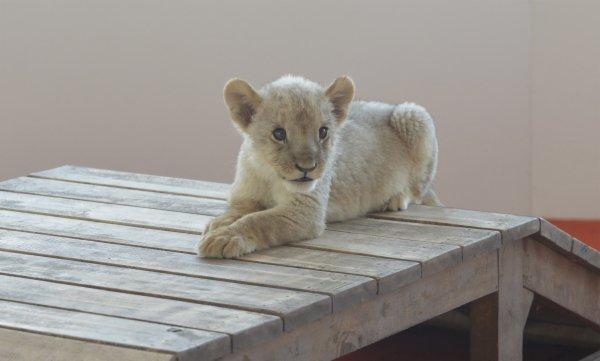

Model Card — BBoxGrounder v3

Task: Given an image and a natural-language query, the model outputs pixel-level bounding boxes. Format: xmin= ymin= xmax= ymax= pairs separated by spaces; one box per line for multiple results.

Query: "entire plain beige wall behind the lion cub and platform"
xmin=0 ymin=0 xmax=600 ymax=217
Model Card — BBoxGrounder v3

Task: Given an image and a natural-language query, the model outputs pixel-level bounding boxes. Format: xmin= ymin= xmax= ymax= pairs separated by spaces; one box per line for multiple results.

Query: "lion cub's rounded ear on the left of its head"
xmin=223 ymin=79 xmax=262 ymax=129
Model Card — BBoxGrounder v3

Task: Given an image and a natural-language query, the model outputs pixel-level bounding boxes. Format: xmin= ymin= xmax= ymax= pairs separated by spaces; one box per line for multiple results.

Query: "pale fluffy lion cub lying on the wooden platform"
xmin=198 ymin=76 xmax=439 ymax=258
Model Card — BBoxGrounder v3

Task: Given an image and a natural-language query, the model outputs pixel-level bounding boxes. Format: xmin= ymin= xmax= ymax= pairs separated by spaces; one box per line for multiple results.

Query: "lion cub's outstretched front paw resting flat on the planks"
xmin=198 ymin=227 xmax=256 ymax=258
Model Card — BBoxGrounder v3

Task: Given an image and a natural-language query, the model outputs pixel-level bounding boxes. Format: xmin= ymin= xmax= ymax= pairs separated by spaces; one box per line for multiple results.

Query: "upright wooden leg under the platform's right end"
xmin=470 ymin=240 xmax=533 ymax=361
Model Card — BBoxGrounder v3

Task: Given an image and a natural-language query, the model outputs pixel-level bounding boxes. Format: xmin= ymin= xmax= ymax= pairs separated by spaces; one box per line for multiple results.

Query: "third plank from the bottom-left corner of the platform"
xmin=0 ymin=275 xmax=283 ymax=350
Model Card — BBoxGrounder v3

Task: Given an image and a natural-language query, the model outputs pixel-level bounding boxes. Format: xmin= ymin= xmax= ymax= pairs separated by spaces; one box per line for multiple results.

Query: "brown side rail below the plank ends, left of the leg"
xmin=224 ymin=253 xmax=498 ymax=361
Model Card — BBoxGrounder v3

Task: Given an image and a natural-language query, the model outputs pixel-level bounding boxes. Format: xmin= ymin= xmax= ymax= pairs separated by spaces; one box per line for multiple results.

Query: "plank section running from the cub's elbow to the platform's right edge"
xmin=298 ymin=231 xmax=462 ymax=277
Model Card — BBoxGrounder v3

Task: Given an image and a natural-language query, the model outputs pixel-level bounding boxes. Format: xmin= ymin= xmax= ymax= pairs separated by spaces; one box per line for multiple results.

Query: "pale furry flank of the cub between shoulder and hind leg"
xmin=327 ymin=101 xmax=409 ymax=222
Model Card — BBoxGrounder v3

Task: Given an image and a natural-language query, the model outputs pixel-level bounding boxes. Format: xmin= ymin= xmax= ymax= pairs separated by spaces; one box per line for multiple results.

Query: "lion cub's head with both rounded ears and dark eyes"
xmin=224 ymin=76 xmax=354 ymax=192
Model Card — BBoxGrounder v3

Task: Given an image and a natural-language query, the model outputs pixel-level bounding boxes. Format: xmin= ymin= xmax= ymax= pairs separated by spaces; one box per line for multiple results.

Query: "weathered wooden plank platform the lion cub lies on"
xmin=0 ymin=166 xmax=600 ymax=361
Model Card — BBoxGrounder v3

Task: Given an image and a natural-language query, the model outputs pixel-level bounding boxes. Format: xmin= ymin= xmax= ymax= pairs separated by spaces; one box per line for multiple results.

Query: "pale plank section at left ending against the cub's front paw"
xmin=0 ymin=210 xmax=199 ymax=254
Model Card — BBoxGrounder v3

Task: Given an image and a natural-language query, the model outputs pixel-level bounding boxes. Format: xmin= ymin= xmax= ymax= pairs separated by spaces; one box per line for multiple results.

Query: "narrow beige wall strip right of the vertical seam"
xmin=531 ymin=0 xmax=600 ymax=218
